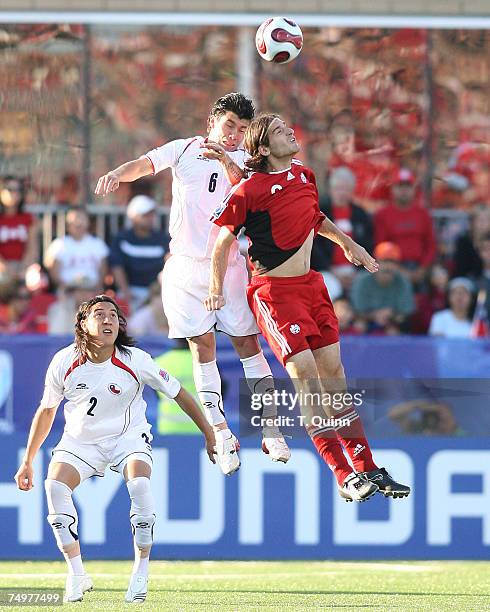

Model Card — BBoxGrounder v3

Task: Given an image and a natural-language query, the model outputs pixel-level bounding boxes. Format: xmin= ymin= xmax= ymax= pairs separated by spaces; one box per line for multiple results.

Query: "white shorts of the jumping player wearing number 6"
xmin=162 ymin=255 xmax=260 ymax=338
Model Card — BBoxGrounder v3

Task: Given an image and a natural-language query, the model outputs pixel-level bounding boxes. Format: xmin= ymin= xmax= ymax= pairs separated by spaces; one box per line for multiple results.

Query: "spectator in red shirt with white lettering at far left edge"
xmin=0 ymin=176 xmax=39 ymax=279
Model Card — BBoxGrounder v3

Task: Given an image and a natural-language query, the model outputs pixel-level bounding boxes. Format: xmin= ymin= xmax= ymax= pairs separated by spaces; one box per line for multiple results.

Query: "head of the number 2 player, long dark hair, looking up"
xmin=75 ymin=295 xmax=135 ymax=359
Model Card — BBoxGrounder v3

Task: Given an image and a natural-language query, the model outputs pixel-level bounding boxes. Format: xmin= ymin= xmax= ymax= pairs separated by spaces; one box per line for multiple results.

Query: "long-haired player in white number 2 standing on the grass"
xmin=15 ymin=295 xmax=215 ymax=602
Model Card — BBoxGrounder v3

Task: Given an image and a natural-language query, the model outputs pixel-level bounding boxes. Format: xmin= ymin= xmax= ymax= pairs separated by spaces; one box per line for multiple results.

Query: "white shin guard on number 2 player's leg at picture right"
xmin=126 ymin=476 xmax=155 ymax=549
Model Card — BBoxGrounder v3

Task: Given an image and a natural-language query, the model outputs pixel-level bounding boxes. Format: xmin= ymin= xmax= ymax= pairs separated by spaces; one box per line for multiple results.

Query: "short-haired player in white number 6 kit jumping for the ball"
xmin=95 ymin=93 xmax=290 ymax=474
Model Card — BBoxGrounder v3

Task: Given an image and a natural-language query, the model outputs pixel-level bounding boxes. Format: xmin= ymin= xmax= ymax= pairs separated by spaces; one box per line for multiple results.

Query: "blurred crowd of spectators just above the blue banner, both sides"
xmin=0 ymin=166 xmax=490 ymax=338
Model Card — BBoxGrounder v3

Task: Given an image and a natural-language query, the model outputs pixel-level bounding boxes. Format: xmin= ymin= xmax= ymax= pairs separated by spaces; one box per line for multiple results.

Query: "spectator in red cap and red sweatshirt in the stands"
xmin=374 ymin=168 xmax=436 ymax=284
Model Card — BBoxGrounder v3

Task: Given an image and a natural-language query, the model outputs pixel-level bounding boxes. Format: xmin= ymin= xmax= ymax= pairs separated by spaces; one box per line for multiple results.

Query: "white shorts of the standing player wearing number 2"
xmin=51 ymin=425 xmax=153 ymax=482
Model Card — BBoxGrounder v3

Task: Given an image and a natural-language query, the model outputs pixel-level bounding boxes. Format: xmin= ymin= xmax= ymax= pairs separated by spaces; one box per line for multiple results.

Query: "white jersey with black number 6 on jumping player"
xmin=146 ymin=136 xmax=247 ymax=262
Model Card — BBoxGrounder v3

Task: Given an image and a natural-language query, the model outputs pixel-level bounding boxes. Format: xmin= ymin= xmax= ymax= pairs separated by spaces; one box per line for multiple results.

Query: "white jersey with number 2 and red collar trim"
xmin=41 ymin=344 xmax=181 ymax=443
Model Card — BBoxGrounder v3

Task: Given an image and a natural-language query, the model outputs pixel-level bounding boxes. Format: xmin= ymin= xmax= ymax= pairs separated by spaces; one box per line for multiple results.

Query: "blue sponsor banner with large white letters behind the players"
xmin=0 ymin=336 xmax=490 ymax=559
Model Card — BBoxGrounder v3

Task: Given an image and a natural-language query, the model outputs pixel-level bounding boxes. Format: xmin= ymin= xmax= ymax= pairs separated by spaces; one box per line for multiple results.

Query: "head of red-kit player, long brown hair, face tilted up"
xmin=245 ymin=113 xmax=299 ymax=172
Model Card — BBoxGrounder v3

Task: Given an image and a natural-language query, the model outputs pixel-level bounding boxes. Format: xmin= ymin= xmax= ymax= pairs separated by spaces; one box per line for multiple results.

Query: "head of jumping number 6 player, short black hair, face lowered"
xmin=208 ymin=92 xmax=255 ymax=151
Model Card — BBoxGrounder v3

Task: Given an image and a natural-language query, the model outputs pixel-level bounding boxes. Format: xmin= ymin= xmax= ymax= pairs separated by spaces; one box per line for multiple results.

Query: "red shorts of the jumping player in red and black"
xmin=247 ymin=270 xmax=339 ymax=365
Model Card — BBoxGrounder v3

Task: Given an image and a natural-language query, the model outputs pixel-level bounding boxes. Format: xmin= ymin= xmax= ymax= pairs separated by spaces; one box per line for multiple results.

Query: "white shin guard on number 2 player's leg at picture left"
xmin=44 ymin=478 xmax=78 ymax=552
